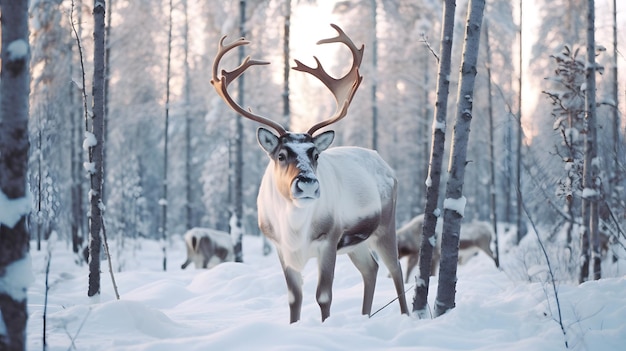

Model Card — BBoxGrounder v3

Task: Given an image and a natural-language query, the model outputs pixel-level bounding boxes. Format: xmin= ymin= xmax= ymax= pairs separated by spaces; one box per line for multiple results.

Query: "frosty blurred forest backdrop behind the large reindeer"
xmin=29 ymin=0 xmax=626 ymax=277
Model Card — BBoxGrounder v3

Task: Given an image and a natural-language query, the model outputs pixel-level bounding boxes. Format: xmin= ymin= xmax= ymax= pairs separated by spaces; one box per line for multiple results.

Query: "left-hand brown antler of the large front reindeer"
xmin=211 ymin=36 xmax=287 ymax=136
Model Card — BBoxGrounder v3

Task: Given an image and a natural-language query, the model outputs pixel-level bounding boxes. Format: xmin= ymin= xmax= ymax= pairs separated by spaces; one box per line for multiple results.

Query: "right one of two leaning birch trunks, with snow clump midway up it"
xmin=435 ymin=0 xmax=485 ymax=316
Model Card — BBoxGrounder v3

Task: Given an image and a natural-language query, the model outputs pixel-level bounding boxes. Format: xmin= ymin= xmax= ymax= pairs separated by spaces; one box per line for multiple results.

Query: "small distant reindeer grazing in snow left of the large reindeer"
xmin=180 ymin=228 xmax=235 ymax=269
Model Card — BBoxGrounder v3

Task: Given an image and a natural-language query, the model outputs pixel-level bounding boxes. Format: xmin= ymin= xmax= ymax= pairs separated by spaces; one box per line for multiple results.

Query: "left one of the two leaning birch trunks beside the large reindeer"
xmin=413 ymin=0 xmax=456 ymax=317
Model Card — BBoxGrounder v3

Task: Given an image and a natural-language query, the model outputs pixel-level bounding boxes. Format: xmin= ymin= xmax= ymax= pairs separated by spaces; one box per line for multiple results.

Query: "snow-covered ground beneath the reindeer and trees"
xmin=27 ymin=231 xmax=626 ymax=351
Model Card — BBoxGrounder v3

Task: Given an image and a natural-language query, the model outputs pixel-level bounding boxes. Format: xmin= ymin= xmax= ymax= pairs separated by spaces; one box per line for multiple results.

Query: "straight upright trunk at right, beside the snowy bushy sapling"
xmin=579 ymin=0 xmax=601 ymax=283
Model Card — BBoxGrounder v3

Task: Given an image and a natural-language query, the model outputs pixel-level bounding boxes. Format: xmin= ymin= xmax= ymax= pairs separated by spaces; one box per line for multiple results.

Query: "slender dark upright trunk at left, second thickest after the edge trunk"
xmin=87 ymin=0 xmax=106 ymax=296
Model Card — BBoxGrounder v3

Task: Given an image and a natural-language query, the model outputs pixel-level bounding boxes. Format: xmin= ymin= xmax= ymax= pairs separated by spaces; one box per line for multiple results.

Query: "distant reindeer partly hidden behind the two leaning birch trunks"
xmin=397 ymin=214 xmax=494 ymax=282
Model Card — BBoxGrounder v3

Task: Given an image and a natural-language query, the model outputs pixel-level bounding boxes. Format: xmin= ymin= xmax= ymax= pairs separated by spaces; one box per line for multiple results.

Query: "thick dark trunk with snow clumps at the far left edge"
xmin=0 ymin=0 xmax=32 ymax=350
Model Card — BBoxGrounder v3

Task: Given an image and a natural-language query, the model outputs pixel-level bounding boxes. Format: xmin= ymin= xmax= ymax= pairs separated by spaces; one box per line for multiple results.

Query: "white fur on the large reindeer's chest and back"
xmin=257 ymin=147 xmax=394 ymax=271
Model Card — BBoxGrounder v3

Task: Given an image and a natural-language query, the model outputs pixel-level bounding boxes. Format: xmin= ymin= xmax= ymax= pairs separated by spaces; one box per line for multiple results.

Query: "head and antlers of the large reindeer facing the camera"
xmin=211 ymin=24 xmax=363 ymax=207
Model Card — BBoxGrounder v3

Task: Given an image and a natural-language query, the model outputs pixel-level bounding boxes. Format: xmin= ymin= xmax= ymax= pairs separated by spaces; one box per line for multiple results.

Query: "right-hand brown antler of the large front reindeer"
xmin=293 ymin=24 xmax=364 ymax=135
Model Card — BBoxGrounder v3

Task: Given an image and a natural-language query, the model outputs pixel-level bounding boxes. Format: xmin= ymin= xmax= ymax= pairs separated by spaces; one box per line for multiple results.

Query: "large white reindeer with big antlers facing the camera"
xmin=211 ymin=24 xmax=408 ymax=323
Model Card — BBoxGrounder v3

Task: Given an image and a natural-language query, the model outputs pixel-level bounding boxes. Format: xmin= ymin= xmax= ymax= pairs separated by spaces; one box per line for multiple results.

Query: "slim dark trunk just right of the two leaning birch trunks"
xmin=484 ymin=21 xmax=500 ymax=267
